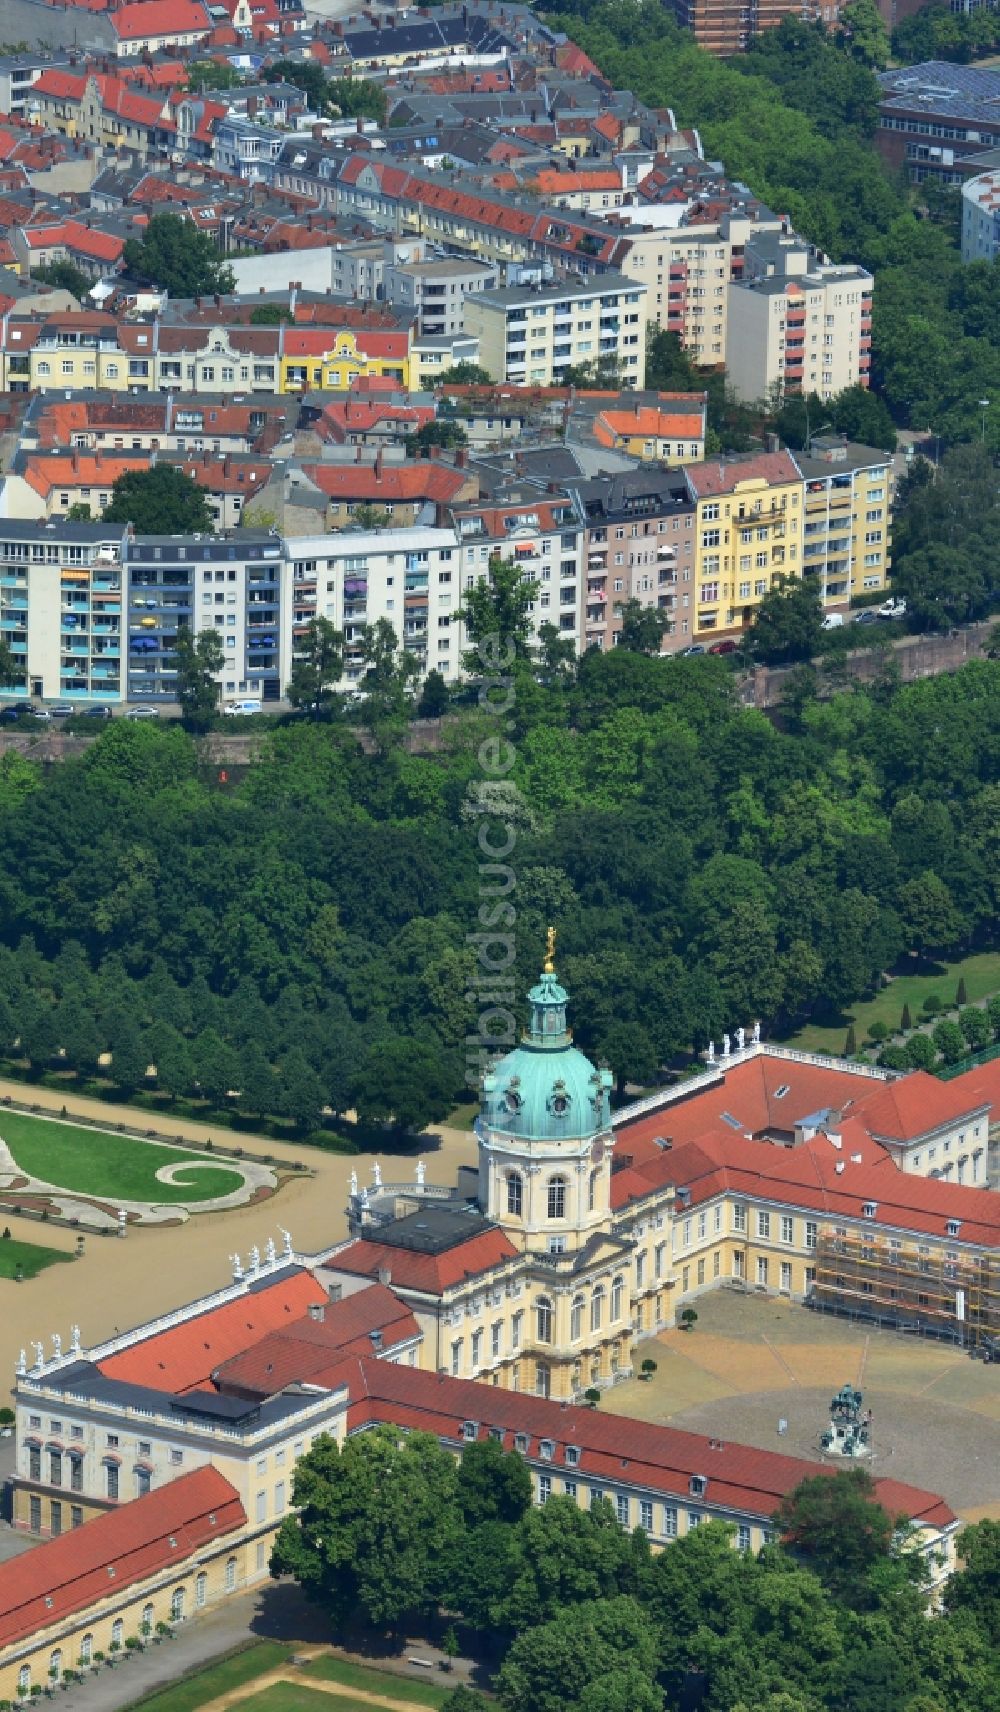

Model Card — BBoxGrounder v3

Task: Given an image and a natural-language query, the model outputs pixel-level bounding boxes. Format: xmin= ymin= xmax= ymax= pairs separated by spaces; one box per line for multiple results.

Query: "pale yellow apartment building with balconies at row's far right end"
xmin=795 ymin=438 xmax=892 ymax=609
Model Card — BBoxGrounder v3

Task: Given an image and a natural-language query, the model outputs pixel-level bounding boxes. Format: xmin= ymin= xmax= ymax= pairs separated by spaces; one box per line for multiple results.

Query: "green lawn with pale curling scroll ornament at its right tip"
xmin=0 ymin=1111 xmax=243 ymax=1204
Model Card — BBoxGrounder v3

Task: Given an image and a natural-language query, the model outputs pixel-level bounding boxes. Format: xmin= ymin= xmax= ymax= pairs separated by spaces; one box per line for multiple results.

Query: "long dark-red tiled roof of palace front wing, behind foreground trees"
xmin=342 ymin=1359 xmax=954 ymax=1527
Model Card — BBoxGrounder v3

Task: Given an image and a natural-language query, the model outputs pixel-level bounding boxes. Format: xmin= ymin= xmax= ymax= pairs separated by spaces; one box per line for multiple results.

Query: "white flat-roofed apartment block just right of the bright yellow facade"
xmin=464 ymin=274 xmax=646 ymax=387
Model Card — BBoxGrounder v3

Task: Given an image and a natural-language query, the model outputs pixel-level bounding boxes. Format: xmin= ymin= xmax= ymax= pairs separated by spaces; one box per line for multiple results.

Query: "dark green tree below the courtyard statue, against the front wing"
xmin=774 ymin=1469 xmax=896 ymax=1606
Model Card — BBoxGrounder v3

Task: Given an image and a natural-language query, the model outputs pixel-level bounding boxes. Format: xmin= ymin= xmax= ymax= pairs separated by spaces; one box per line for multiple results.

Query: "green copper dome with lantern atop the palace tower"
xmin=481 ymin=967 xmax=611 ymax=1142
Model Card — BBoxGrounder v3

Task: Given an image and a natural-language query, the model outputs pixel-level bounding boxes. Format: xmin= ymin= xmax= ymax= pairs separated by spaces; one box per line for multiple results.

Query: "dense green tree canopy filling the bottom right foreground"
xmin=272 ymin=1428 xmax=1000 ymax=1712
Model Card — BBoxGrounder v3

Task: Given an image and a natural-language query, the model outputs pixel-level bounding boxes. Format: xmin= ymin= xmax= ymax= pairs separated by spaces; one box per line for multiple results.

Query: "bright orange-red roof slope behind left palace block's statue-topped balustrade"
xmin=98 ymin=1267 xmax=327 ymax=1394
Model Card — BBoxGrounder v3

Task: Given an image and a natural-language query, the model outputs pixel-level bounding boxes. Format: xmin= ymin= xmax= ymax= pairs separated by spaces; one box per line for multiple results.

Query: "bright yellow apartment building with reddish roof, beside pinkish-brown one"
xmin=678 ymin=452 xmax=805 ymax=642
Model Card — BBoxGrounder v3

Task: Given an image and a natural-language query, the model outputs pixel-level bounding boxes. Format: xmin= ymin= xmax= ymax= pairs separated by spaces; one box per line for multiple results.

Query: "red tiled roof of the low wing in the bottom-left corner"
xmin=0 ymin=1467 xmax=247 ymax=1647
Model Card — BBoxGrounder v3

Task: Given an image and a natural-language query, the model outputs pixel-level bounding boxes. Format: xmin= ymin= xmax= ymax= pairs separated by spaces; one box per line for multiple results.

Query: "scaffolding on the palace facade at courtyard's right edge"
xmin=808 ymin=1228 xmax=1000 ymax=1351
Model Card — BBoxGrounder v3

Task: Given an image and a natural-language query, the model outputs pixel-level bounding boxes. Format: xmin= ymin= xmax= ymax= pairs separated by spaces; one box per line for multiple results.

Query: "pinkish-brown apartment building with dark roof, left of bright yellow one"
xmin=574 ymin=469 xmax=695 ymax=652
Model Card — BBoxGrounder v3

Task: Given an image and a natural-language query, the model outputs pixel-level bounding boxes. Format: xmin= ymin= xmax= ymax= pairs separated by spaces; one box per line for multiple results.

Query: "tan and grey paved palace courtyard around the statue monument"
xmin=619 ymin=1289 xmax=1000 ymax=1520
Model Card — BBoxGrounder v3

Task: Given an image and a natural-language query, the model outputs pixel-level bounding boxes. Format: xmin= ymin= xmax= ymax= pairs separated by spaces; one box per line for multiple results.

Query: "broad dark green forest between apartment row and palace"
xmin=0 ymin=649 xmax=1000 ymax=1133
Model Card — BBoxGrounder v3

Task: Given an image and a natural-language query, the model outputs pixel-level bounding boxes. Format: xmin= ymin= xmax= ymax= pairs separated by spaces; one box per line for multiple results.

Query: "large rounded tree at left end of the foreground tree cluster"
xmin=271 ymin=1426 xmax=461 ymax=1633
